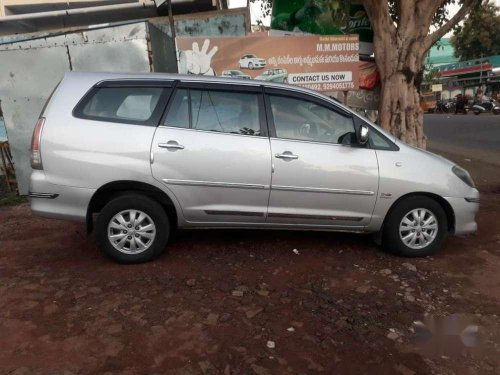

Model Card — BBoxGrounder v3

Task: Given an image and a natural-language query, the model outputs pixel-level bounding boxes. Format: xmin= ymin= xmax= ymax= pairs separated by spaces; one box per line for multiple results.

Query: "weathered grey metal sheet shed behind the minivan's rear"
xmin=0 ymin=9 xmax=249 ymax=195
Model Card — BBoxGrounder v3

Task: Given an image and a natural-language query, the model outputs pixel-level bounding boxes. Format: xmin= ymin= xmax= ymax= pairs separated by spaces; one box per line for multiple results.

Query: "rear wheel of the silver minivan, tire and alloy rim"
xmin=96 ymin=193 xmax=170 ymax=264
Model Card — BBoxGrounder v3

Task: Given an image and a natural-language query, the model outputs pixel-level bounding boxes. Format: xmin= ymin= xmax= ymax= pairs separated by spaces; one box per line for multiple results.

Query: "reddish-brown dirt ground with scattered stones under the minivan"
xmin=0 ymin=151 xmax=500 ymax=375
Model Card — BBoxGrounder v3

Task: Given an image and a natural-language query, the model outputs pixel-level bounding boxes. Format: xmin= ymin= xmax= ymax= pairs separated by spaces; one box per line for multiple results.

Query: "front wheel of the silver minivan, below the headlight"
xmin=382 ymin=196 xmax=448 ymax=257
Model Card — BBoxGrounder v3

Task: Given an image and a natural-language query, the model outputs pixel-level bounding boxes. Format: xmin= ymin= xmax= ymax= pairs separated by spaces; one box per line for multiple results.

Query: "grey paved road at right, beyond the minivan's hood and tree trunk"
xmin=424 ymin=113 xmax=500 ymax=165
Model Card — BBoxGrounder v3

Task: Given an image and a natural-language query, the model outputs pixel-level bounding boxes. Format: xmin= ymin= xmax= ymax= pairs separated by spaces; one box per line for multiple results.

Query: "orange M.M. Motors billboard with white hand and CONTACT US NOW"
xmin=176 ymin=35 xmax=359 ymax=92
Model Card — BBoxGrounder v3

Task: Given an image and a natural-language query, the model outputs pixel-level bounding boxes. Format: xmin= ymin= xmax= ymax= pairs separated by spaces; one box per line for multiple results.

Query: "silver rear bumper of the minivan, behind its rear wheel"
xmin=29 ymin=170 xmax=95 ymax=222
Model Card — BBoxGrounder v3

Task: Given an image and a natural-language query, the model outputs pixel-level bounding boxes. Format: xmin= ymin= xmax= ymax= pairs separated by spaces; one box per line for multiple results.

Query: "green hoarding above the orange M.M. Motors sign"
xmin=271 ymin=0 xmax=373 ymax=55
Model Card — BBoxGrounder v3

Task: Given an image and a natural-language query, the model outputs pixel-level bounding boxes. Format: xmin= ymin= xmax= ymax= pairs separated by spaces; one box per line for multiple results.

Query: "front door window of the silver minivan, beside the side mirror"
xmin=269 ymin=95 xmax=356 ymax=144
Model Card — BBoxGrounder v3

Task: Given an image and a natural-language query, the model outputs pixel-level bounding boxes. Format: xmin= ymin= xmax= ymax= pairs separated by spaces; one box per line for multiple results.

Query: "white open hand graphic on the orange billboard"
xmin=179 ymin=39 xmax=219 ymax=76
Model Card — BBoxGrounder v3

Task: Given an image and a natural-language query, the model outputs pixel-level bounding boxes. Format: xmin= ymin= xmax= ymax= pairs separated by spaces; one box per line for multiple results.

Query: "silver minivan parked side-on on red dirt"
xmin=30 ymin=73 xmax=479 ymax=263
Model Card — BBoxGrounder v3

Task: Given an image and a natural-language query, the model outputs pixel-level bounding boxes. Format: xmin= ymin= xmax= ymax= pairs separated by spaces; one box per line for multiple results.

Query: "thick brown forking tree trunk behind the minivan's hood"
xmin=363 ymin=0 xmax=480 ymax=148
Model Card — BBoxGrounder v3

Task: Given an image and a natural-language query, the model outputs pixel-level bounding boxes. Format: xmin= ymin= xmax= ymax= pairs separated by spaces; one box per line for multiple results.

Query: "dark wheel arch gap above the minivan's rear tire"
xmin=86 ymin=180 xmax=178 ymax=233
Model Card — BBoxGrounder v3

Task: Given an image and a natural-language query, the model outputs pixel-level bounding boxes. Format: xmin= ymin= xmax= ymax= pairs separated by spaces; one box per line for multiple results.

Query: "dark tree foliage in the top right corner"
xmin=451 ymin=1 xmax=500 ymax=60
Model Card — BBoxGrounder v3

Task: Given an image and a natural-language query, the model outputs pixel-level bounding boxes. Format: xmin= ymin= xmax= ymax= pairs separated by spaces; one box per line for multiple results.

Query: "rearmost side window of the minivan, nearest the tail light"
xmin=75 ymin=87 xmax=165 ymax=125
